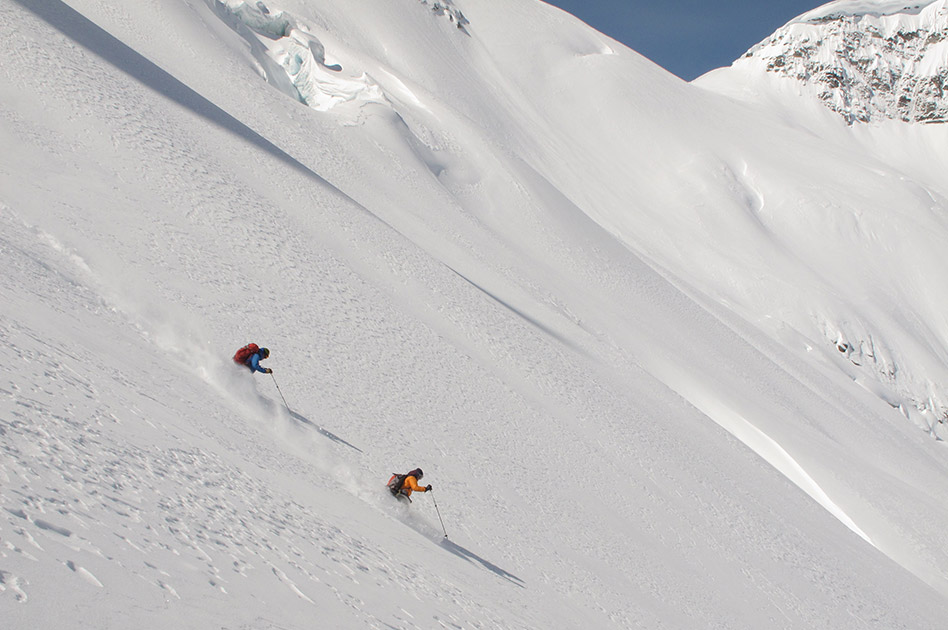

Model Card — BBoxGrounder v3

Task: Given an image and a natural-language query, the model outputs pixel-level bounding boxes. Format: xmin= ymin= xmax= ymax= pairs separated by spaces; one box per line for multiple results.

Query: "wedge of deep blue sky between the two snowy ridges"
xmin=545 ymin=0 xmax=826 ymax=81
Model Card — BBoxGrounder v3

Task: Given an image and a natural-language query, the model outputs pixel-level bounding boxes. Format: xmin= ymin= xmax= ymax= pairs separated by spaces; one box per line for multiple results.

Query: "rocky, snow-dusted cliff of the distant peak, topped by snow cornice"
xmin=724 ymin=0 xmax=948 ymax=124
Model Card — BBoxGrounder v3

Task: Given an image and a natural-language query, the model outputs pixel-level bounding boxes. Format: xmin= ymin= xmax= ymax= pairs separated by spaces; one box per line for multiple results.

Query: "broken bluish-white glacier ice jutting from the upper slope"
xmin=208 ymin=0 xmax=385 ymax=112
